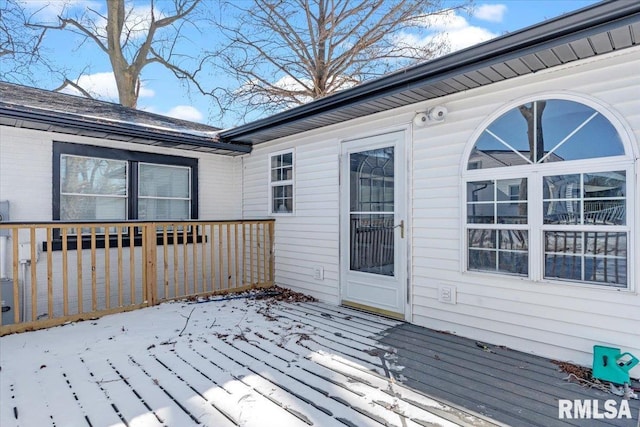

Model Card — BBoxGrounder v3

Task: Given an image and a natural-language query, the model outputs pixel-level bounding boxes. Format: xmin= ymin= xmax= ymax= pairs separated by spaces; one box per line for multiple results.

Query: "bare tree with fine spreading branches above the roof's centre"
xmin=211 ymin=0 xmax=470 ymax=120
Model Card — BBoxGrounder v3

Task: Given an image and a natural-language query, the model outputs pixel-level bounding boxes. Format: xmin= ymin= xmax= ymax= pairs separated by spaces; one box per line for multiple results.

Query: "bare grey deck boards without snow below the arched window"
xmin=380 ymin=324 xmax=640 ymax=427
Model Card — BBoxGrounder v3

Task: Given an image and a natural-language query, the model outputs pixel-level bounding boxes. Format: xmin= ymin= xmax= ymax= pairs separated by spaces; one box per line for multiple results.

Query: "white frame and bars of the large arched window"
xmin=460 ymin=92 xmax=639 ymax=291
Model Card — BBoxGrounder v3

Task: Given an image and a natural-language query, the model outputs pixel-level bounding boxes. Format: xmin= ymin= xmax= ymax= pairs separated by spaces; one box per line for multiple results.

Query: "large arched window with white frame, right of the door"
xmin=464 ymin=99 xmax=634 ymax=288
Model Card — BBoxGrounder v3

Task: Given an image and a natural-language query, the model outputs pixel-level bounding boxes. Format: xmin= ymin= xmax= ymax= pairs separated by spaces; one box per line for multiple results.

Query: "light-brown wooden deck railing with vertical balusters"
xmin=0 ymin=220 xmax=274 ymax=335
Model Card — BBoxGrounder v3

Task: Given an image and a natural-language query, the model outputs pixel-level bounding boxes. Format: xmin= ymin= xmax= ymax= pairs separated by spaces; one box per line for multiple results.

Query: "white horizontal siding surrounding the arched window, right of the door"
xmin=412 ymin=49 xmax=640 ymax=377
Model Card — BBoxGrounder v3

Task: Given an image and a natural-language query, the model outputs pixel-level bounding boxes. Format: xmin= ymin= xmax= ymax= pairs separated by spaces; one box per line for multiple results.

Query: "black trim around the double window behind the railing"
xmin=51 ymin=141 xmax=199 ymax=250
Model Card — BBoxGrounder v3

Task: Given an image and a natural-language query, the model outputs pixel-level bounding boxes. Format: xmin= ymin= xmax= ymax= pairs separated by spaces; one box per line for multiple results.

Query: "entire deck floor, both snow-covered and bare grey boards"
xmin=0 ymin=298 xmax=638 ymax=427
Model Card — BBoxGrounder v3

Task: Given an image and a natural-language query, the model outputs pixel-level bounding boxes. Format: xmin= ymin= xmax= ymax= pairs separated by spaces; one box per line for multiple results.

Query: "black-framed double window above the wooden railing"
xmin=53 ymin=142 xmax=198 ymax=239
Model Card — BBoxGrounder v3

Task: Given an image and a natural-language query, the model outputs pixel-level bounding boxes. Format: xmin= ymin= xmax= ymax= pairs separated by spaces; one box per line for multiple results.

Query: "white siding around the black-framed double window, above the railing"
xmin=0 ymin=126 xmax=242 ymax=221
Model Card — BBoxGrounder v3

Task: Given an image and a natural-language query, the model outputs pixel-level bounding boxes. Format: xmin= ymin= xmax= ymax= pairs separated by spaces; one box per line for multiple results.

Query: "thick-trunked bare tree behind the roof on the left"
xmin=25 ymin=0 xmax=209 ymax=107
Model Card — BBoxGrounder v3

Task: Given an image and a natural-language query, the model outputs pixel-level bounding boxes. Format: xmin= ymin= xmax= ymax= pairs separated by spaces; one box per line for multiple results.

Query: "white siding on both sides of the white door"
xmin=243 ymin=48 xmax=640 ymax=377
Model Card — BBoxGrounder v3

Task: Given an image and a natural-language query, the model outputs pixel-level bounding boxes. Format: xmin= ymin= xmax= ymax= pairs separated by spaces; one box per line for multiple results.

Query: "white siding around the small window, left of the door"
xmin=243 ymin=140 xmax=339 ymax=303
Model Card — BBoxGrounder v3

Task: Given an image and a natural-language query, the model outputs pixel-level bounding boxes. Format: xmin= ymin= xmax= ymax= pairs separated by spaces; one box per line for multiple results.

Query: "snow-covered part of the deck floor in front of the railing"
xmin=0 ymin=299 xmax=491 ymax=427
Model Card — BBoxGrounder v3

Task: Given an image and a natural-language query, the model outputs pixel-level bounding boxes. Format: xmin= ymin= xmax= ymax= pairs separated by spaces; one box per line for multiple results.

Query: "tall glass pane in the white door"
xmin=349 ymin=147 xmax=395 ymax=276
